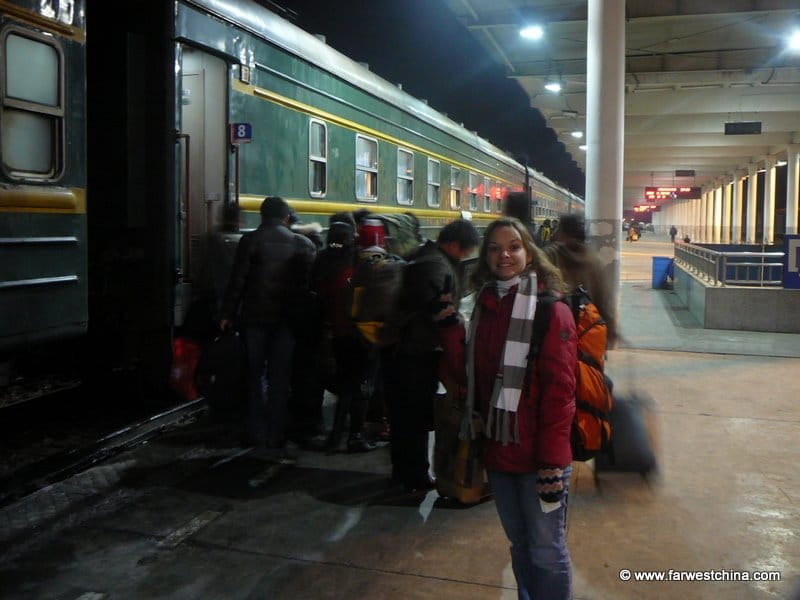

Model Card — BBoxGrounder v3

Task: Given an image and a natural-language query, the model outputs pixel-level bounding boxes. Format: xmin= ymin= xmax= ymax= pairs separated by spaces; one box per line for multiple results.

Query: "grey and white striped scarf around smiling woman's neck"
xmin=461 ymin=272 xmax=537 ymax=444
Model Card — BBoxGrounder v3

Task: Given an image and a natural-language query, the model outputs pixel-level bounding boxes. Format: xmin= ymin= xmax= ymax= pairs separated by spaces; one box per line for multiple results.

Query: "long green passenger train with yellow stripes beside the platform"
xmin=0 ymin=0 xmax=583 ymax=405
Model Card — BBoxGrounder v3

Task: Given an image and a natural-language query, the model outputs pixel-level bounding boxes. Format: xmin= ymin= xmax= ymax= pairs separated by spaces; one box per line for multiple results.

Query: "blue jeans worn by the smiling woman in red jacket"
xmin=488 ymin=467 xmax=572 ymax=600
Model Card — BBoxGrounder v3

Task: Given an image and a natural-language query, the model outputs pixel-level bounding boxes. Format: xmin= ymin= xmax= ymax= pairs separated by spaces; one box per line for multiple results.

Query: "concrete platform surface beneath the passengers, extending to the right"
xmin=0 ymin=237 xmax=800 ymax=600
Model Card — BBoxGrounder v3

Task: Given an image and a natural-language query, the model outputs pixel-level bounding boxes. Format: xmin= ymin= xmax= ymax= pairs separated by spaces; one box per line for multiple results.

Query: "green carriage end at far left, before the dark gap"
xmin=0 ymin=0 xmax=89 ymax=405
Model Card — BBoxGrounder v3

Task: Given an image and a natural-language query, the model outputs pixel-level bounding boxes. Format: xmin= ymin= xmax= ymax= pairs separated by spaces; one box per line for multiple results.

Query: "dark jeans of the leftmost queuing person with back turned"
xmin=243 ymin=323 xmax=294 ymax=448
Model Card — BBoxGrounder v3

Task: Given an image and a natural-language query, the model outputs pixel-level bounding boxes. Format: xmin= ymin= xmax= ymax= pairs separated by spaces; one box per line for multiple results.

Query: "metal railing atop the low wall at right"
xmin=675 ymin=242 xmax=784 ymax=287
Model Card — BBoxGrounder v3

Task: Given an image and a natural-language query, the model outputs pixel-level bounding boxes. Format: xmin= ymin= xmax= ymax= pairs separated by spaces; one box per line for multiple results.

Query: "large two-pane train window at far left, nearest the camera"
xmin=0 ymin=29 xmax=64 ymax=179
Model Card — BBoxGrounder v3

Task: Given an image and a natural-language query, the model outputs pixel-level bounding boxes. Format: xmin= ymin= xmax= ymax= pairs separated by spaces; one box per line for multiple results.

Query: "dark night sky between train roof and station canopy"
xmin=265 ymin=0 xmax=585 ymax=196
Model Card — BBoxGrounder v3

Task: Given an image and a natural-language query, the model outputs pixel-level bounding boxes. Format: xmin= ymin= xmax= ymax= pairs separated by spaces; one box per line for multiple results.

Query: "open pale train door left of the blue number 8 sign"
xmin=175 ymin=46 xmax=228 ymax=325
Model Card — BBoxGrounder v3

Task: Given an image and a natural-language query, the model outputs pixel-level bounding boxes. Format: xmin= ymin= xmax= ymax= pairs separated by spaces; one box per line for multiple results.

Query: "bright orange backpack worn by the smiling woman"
xmin=531 ymin=286 xmax=613 ymax=461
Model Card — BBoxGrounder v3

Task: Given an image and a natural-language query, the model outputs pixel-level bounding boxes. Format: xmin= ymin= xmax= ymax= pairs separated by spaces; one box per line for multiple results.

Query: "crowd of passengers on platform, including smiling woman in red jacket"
xmin=189 ymin=195 xmax=616 ymax=598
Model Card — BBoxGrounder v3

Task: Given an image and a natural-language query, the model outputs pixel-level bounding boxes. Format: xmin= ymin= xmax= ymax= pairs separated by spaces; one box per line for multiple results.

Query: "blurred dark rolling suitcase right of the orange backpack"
xmin=595 ymin=392 xmax=658 ymax=478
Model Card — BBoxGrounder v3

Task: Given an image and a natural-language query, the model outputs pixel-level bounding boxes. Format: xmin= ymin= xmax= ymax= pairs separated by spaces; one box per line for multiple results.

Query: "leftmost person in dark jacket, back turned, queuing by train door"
xmin=220 ymin=196 xmax=316 ymax=462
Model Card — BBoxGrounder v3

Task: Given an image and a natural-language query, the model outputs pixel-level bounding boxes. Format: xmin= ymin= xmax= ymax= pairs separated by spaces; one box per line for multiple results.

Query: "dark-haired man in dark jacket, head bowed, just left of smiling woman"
xmin=381 ymin=219 xmax=479 ymax=491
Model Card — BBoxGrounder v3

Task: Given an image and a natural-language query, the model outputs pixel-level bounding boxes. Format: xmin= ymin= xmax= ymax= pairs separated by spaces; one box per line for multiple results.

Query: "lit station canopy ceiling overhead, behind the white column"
xmin=444 ymin=0 xmax=800 ymax=208
